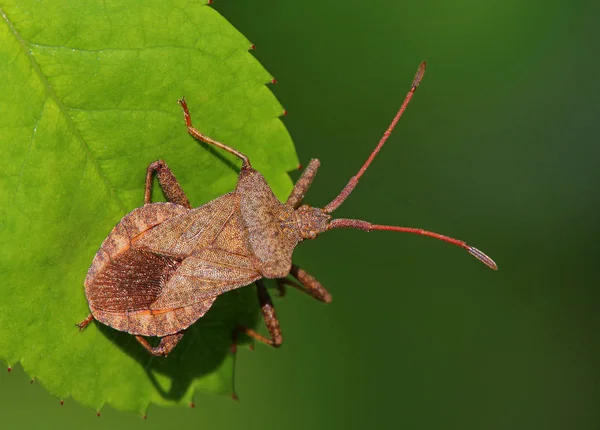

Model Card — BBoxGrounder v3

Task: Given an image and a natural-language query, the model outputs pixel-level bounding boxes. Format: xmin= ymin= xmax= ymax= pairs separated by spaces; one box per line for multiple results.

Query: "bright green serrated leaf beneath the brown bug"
xmin=0 ymin=0 xmax=298 ymax=414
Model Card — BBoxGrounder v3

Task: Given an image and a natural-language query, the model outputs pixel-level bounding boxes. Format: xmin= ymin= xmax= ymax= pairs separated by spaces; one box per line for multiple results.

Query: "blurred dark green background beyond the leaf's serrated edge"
xmin=0 ymin=0 xmax=600 ymax=430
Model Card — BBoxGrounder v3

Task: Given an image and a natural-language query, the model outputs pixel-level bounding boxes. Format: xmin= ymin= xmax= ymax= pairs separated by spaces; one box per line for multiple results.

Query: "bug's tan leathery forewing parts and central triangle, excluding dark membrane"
xmin=133 ymin=193 xmax=262 ymax=310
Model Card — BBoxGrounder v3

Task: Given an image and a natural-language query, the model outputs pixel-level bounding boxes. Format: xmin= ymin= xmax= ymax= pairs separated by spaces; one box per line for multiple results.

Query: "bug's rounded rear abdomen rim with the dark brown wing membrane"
xmin=85 ymin=203 xmax=215 ymax=336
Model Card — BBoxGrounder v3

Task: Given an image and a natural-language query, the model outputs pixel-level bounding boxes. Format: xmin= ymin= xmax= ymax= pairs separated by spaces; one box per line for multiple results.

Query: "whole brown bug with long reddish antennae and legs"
xmin=78 ymin=62 xmax=497 ymax=356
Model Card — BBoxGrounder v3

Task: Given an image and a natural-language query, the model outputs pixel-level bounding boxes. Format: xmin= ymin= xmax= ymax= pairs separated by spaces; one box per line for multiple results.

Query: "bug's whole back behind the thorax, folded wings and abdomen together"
xmin=85 ymin=193 xmax=261 ymax=336
